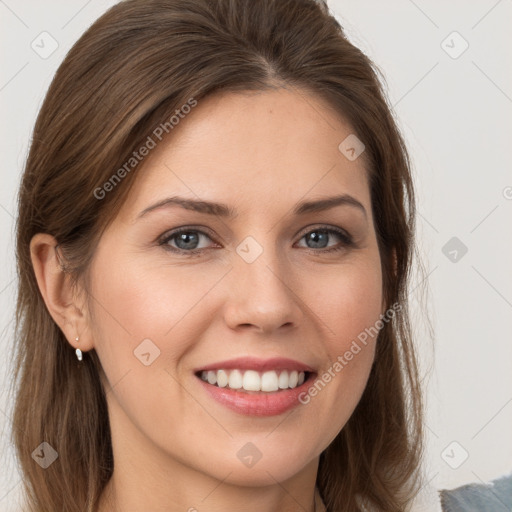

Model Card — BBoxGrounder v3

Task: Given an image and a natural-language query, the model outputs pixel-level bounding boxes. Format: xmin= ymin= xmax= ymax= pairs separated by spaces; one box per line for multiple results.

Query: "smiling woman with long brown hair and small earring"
xmin=14 ymin=0 xmax=428 ymax=512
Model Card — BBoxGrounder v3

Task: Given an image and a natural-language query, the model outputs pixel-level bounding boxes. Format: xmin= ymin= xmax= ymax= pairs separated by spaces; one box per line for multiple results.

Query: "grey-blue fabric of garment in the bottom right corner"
xmin=439 ymin=473 xmax=512 ymax=512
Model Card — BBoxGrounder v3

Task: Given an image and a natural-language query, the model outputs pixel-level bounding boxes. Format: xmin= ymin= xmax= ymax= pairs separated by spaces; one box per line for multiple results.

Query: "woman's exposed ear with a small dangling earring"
xmin=30 ymin=233 xmax=94 ymax=352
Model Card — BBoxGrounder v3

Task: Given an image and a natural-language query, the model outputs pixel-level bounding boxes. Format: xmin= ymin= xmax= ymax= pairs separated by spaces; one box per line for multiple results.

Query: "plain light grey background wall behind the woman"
xmin=0 ymin=0 xmax=512 ymax=511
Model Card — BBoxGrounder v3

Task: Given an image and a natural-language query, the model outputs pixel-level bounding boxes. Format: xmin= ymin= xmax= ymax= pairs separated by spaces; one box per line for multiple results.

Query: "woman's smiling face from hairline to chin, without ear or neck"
xmin=90 ymin=89 xmax=384 ymax=485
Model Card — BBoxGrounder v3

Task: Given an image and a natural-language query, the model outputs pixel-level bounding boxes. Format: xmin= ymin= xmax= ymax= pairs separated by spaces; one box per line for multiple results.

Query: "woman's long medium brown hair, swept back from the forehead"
xmin=13 ymin=0 xmax=423 ymax=512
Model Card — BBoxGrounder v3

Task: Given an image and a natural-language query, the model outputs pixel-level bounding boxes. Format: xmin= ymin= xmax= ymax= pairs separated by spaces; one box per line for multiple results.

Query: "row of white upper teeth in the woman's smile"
xmin=201 ymin=370 xmax=306 ymax=393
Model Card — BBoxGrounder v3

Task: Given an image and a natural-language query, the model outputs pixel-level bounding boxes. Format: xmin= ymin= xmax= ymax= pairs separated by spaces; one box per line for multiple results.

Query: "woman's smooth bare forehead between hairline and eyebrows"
xmin=117 ymin=88 xmax=369 ymax=222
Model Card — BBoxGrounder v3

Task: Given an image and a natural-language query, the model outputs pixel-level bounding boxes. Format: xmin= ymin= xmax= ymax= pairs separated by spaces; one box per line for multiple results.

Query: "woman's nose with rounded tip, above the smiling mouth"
xmin=224 ymin=246 xmax=303 ymax=334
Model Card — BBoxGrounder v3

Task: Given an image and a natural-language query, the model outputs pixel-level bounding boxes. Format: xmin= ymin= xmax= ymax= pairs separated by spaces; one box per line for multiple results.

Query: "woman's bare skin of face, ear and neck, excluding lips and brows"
xmin=31 ymin=88 xmax=385 ymax=512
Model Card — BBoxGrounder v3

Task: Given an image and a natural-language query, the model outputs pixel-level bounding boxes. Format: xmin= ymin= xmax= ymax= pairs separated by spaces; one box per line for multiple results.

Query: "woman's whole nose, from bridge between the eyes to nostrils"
xmin=226 ymin=233 xmax=301 ymax=332
